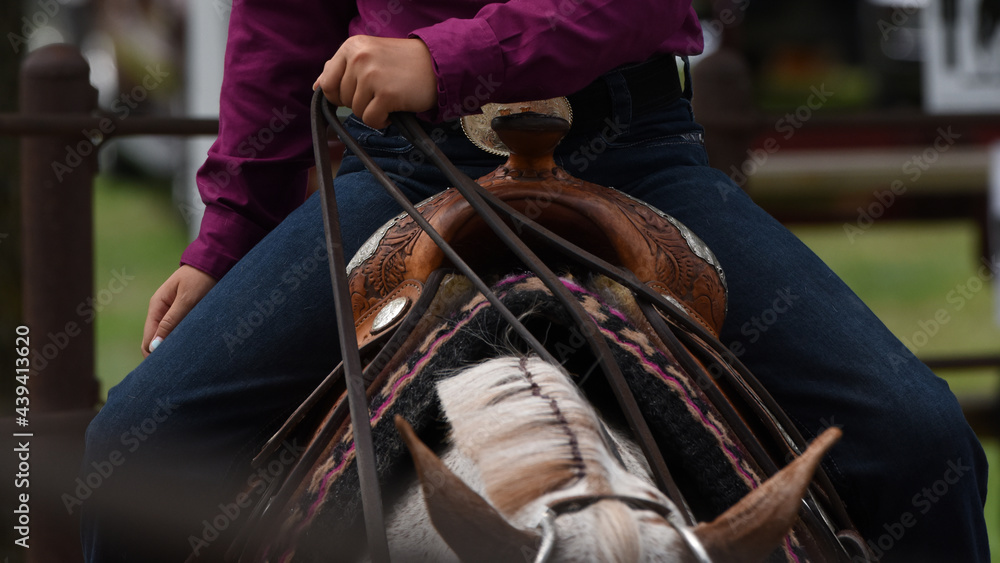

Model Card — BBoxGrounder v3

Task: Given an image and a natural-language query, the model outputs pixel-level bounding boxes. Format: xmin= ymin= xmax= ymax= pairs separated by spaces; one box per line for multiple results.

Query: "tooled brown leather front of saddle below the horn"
xmin=348 ymin=138 xmax=726 ymax=346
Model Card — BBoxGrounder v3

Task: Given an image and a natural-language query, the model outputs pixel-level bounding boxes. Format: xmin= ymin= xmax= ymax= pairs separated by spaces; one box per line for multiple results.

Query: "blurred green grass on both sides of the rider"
xmin=94 ymin=176 xmax=1000 ymax=562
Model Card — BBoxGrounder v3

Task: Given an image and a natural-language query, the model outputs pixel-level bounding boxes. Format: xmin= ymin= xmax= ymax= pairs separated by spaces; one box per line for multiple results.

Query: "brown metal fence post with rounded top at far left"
xmin=20 ymin=45 xmax=99 ymax=412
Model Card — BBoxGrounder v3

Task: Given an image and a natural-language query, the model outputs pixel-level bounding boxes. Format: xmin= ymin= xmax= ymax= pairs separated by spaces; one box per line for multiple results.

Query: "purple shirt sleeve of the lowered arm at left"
xmin=181 ymin=0 xmax=356 ymax=278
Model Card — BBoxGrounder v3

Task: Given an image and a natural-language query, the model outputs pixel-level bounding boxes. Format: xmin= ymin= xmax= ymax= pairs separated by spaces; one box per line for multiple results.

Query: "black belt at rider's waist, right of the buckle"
xmin=567 ymin=55 xmax=684 ymax=134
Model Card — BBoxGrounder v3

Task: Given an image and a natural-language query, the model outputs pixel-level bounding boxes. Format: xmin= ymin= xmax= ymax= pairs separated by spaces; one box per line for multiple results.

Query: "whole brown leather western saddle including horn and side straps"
xmin=230 ymin=99 xmax=875 ymax=562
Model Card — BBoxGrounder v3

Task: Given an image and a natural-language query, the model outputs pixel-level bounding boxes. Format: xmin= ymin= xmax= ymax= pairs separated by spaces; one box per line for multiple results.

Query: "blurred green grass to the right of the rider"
xmin=792 ymin=221 xmax=1000 ymax=562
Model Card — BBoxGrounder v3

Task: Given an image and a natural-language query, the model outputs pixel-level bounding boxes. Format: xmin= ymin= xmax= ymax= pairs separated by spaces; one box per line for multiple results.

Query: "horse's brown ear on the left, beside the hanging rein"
xmin=395 ymin=415 xmax=540 ymax=562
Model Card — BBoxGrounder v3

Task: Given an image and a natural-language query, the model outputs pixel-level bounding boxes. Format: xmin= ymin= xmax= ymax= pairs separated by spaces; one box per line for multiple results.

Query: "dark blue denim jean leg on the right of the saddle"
xmin=560 ymin=100 xmax=989 ymax=562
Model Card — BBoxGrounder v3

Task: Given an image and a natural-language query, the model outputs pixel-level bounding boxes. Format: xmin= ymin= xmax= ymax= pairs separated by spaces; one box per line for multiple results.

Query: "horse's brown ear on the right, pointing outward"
xmin=694 ymin=428 xmax=841 ymax=563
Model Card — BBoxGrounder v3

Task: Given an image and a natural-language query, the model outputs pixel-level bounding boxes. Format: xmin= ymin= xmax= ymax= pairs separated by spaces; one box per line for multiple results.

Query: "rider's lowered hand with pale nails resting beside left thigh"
xmin=142 ymin=265 xmax=216 ymax=358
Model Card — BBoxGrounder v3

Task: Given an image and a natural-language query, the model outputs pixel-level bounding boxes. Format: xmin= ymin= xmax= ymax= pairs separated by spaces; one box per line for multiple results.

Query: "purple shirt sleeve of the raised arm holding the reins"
xmin=411 ymin=0 xmax=702 ymax=120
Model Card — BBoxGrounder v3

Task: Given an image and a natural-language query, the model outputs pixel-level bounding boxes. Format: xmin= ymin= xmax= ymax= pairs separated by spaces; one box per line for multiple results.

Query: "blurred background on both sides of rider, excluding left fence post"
xmin=0 ymin=0 xmax=1000 ymax=561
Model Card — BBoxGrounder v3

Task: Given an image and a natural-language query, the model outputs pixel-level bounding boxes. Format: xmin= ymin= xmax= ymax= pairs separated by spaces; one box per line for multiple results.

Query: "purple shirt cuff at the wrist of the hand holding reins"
xmin=410 ymin=18 xmax=505 ymax=121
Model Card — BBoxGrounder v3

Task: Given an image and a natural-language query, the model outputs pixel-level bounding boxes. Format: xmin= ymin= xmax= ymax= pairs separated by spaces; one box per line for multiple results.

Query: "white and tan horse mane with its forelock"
xmin=438 ymin=357 xmax=663 ymax=562
